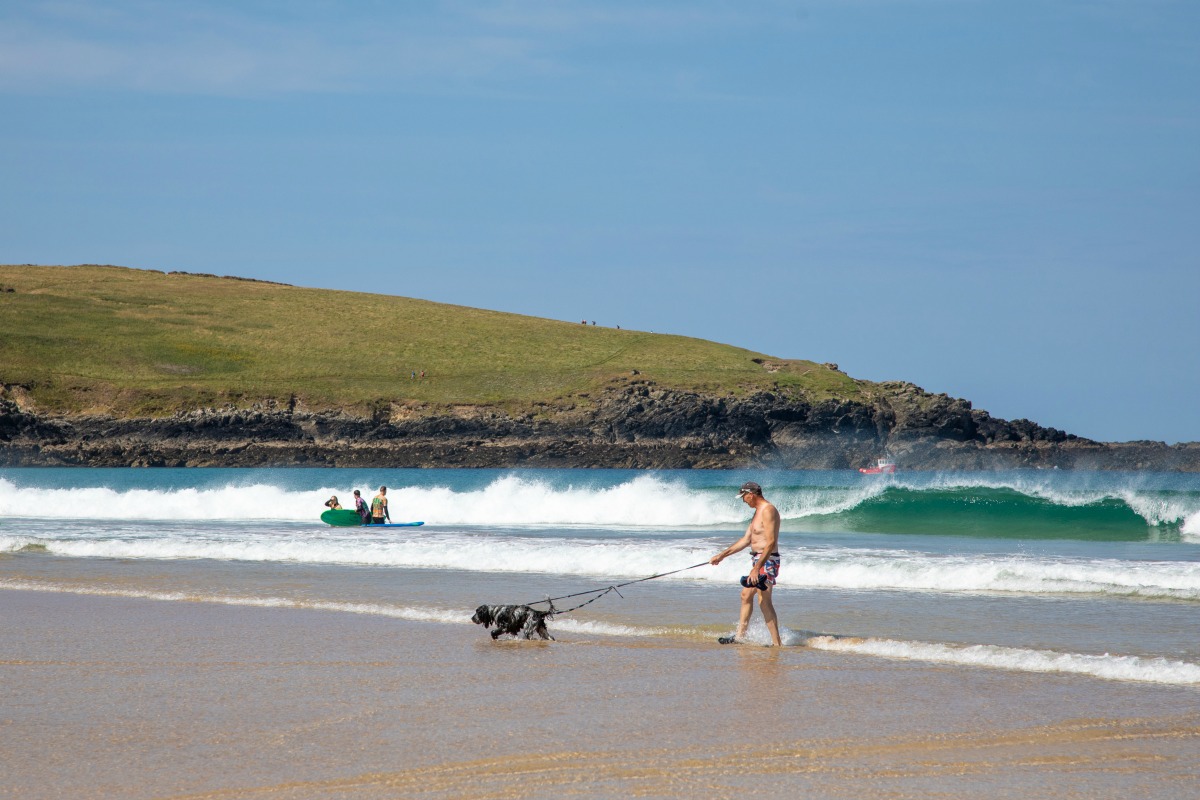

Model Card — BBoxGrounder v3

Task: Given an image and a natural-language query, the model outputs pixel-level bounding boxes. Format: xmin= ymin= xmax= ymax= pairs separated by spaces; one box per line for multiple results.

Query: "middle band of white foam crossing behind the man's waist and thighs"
xmin=0 ymin=529 xmax=1200 ymax=601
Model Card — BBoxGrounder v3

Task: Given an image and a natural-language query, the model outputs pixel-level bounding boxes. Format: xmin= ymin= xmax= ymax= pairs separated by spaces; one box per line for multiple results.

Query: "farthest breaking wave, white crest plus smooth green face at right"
xmin=0 ymin=474 xmax=1200 ymax=541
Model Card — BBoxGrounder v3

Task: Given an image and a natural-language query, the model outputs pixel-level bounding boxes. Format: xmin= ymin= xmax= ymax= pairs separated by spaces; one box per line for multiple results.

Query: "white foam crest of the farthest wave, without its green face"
xmin=0 ymin=474 xmax=1200 ymax=536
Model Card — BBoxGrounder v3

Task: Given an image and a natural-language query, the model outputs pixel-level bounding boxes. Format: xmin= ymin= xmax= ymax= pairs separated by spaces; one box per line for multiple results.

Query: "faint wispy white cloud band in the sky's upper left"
xmin=0 ymin=2 xmax=561 ymax=95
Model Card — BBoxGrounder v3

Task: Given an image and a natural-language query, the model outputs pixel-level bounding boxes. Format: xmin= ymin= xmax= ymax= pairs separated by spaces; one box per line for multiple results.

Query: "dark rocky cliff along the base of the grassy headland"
xmin=0 ymin=378 xmax=1200 ymax=471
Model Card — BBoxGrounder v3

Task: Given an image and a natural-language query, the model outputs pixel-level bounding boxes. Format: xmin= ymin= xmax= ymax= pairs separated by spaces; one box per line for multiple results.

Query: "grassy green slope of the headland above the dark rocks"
xmin=0 ymin=265 xmax=870 ymax=416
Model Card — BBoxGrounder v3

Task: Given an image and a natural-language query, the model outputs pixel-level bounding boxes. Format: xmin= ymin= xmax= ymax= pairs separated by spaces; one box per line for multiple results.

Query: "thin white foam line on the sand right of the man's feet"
xmin=804 ymin=636 xmax=1200 ymax=686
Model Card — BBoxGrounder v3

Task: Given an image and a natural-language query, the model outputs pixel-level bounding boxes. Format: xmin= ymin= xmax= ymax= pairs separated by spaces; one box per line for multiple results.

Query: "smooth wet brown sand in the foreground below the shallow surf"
xmin=0 ymin=590 xmax=1200 ymax=800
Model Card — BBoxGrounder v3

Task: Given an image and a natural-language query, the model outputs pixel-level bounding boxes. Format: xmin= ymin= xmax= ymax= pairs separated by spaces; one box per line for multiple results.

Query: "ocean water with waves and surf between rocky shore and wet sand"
xmin=0 ymin=469 xmax=1200 ymax=687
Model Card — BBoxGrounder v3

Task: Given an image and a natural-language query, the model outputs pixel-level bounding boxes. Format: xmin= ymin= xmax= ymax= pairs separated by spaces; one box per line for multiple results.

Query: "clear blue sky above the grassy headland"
xmin=7 ymin=0 xmax=1200 ymax=443
